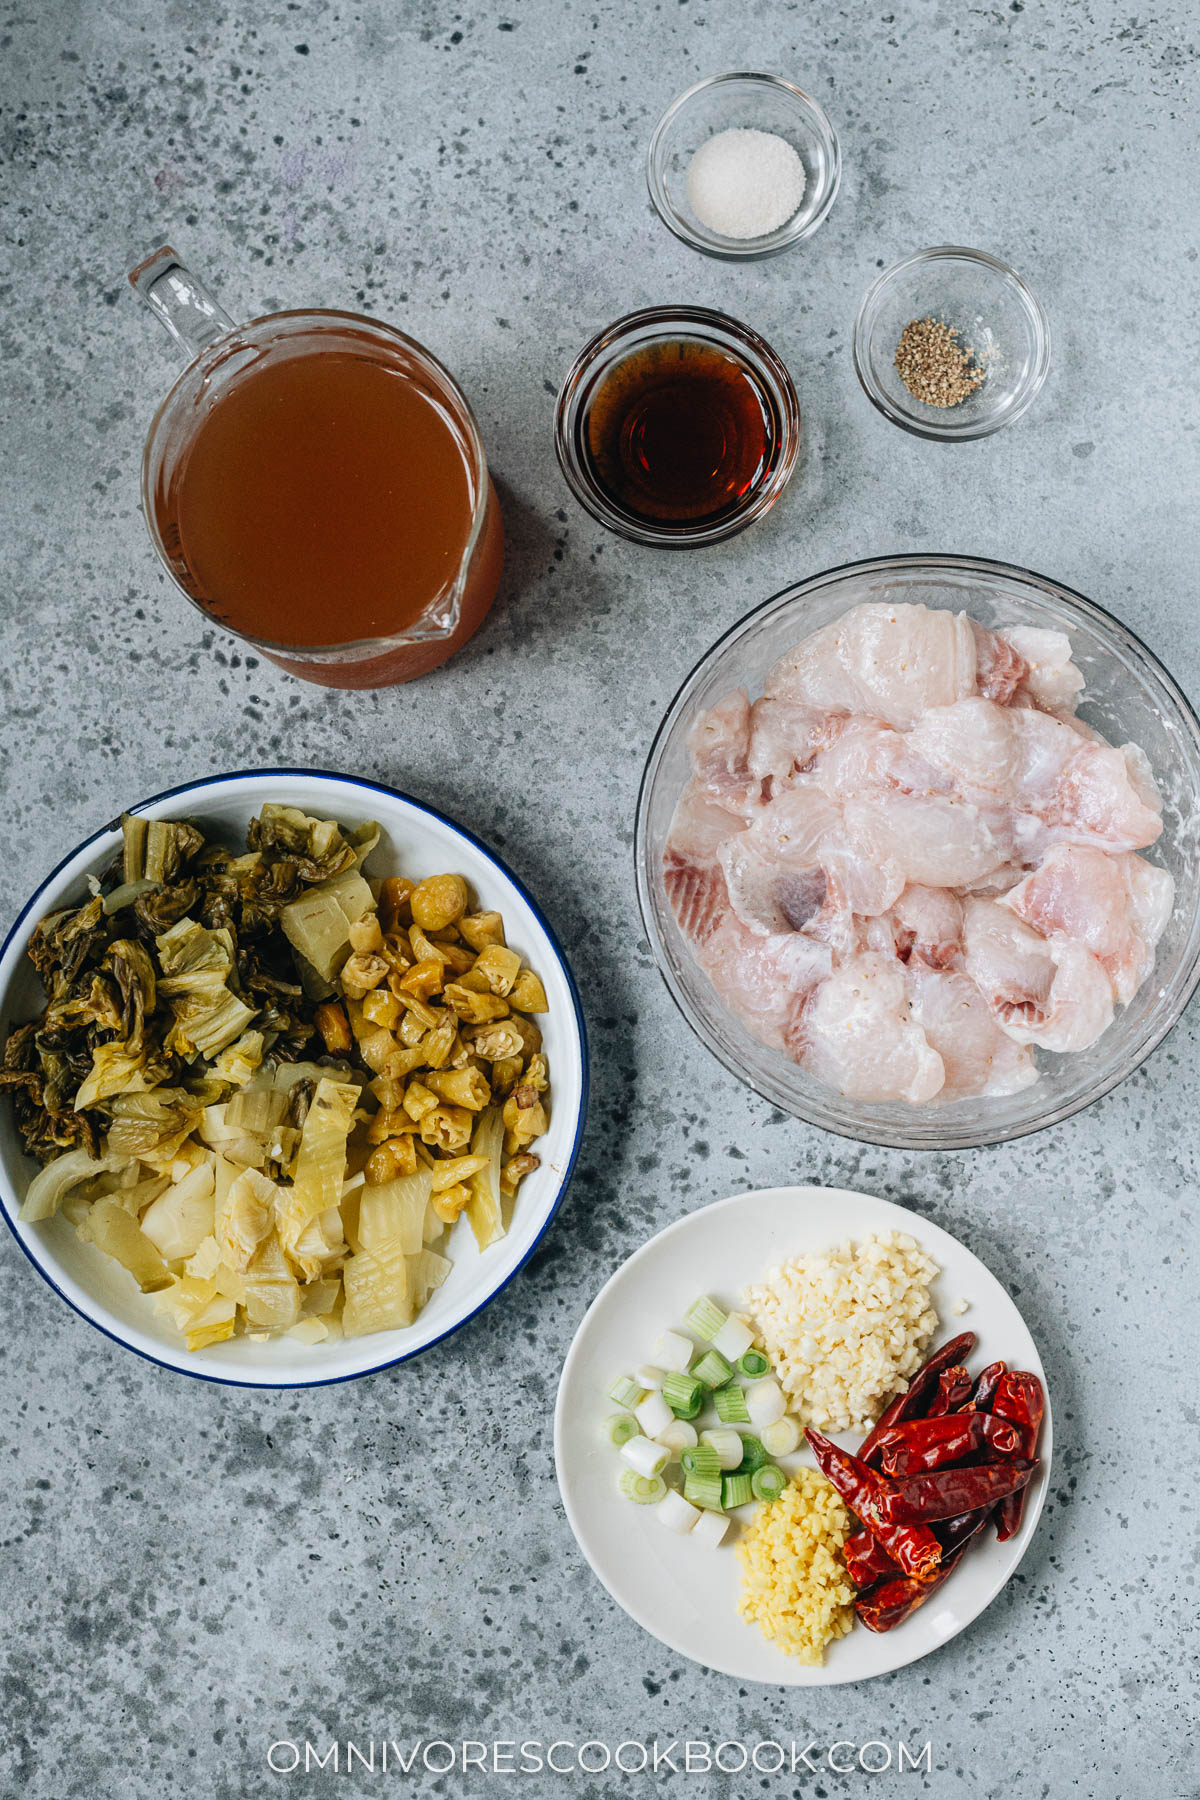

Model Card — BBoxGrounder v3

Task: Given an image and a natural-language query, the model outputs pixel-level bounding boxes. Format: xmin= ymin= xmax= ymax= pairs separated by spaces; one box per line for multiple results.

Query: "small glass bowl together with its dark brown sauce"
xmin=554 ymin=306 xmax=801 ymax=549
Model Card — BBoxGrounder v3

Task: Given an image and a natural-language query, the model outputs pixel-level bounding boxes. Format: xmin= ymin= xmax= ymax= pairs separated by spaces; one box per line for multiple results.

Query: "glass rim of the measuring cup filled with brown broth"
xmin=140 ymin=306 xmax=489 ymax=664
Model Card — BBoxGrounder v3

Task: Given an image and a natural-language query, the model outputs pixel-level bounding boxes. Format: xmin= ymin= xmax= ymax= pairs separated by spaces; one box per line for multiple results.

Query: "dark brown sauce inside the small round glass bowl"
xmin=583 ymin=338 xmax=777 ymax=526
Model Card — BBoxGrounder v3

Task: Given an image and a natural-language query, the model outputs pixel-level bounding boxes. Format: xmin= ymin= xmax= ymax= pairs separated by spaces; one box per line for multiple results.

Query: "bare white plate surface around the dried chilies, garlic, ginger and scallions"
xmin=554 ymin=1188 xmax=1052 ymax=1687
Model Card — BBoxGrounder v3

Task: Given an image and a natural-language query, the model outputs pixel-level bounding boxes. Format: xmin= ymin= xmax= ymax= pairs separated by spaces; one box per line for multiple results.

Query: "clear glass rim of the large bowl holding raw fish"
xmin=633 ymin=551 xmax=1200 ymax=1154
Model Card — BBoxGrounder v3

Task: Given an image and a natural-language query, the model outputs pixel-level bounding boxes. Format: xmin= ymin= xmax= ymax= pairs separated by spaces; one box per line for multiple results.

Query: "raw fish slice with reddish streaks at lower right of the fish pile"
xmin=963 ymin=900 xmax=1112 ymax=1053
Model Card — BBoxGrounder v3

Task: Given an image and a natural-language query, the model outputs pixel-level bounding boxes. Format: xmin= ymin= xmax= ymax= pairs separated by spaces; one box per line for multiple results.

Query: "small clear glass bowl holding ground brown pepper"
xmin=855 ymin=245 xmax=1051 ymax=443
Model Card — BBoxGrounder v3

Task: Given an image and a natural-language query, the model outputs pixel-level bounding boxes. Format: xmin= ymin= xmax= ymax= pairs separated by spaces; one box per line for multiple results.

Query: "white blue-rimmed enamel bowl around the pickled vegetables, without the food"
xmin=0 ymin=769 xmax=588 ymax=1388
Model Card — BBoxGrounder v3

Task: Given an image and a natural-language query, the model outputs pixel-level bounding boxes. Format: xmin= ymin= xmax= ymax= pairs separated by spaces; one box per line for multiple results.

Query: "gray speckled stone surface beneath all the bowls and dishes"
xmin=0 ymin=0 xmax=1200 ymax=1800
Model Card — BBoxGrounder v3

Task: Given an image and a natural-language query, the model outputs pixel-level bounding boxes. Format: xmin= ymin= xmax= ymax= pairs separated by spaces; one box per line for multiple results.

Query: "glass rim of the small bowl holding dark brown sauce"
xmin=554 ymin=306 xmax=804 ymax=549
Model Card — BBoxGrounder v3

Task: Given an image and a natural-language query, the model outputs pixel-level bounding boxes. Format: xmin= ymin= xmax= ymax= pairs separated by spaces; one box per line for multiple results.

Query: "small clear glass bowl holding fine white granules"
xmin=646 ymin=70 xmax=842 ymax=263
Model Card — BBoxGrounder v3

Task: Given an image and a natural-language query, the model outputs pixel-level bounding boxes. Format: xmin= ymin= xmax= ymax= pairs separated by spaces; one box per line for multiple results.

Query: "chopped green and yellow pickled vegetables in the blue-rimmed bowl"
xmin=0 ymin=803 xmax=550 ymax=1353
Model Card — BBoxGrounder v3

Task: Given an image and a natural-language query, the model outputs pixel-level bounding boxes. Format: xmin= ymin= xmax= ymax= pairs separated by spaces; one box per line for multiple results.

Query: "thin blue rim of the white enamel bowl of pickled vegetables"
xmin=0 ymin=767 xmax=590 ymax=1393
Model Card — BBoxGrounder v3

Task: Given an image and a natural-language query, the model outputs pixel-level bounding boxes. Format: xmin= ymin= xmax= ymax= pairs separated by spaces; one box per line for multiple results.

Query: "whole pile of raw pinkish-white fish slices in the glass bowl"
xmin=664 ymin=603 xmax=1175 ymax=1105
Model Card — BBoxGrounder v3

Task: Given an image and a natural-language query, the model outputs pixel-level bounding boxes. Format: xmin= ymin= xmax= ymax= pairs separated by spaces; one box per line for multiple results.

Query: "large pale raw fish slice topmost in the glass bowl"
xmin=765 ymin=601 xmax=977 ymax=731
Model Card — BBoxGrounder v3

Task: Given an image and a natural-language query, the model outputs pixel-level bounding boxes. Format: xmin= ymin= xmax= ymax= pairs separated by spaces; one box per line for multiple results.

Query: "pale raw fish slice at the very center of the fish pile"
xmin=842 ymin=794 xmax=1007 ymax=887
